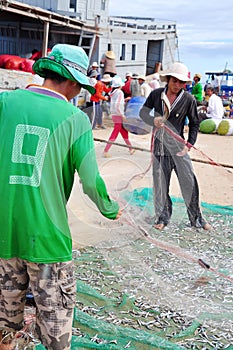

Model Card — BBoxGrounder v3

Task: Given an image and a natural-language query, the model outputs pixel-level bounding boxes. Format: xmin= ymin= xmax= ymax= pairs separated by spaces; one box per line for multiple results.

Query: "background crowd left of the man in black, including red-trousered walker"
xmin=73 ymin=55 xmax=160 ymax=158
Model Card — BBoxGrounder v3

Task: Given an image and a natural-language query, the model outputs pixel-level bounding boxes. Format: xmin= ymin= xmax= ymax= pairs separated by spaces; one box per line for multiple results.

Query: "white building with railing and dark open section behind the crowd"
xmin=0 ymin=0 xmax=177 ymax=76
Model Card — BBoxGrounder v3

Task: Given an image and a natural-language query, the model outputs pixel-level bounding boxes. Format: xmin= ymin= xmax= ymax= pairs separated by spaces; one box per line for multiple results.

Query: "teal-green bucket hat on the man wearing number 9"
xmin=32 ymin=44 xmax=95 ymax=94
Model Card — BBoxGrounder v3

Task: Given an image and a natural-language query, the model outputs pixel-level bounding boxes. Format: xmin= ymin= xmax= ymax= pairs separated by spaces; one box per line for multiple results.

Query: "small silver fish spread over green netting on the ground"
xmin=73 ymin=208 xmax=233 ymax=350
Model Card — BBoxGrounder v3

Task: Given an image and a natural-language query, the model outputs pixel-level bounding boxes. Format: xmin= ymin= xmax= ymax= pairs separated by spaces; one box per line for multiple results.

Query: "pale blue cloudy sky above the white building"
xmin=109 ymin=0 xmax=233 ymax=82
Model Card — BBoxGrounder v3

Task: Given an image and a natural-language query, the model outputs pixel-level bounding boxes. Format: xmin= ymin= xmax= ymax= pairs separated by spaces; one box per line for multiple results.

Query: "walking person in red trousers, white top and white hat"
xmin=103 ymin=76 xmax=134 ymax=158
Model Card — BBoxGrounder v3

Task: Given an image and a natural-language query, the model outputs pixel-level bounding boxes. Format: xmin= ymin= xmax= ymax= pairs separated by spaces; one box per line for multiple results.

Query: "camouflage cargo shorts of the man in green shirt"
xmin=0 ymin=258 xmax=76 ymax=350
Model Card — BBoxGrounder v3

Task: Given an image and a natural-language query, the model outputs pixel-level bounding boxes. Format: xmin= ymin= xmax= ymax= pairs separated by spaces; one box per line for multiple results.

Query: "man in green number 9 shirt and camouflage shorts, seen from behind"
xmin=0 ymin=44 xmax=121 ymax=350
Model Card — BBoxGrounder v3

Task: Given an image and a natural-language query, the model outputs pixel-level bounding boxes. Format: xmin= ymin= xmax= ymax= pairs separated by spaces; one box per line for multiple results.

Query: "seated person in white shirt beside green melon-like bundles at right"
xmin=199 ymin=86 xmax=225 ymax=120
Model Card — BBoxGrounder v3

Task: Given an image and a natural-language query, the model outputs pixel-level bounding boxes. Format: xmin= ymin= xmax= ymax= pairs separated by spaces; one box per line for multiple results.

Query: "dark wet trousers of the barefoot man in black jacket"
xmin=153 ymin=154 xmax=206 ymax=227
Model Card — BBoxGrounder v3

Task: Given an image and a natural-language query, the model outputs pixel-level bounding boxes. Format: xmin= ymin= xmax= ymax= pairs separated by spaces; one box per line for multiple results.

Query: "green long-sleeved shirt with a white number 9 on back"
xmin=0 ymin=90 xmax=119 ymax=263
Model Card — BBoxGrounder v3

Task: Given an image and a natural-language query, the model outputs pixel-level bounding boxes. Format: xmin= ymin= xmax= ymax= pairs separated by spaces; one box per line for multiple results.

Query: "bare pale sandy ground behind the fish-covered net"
xmin=68 ymin=120 xmax=233 ymax=248
